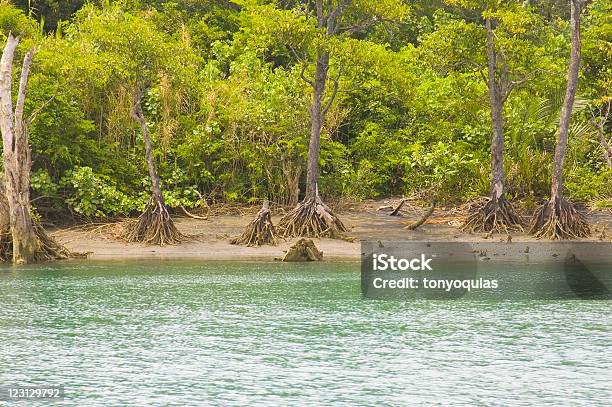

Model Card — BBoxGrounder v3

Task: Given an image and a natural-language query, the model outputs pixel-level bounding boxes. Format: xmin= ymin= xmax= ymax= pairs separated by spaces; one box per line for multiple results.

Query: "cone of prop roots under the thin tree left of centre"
xmin=119 ymin=199 xmax=192 ymax=246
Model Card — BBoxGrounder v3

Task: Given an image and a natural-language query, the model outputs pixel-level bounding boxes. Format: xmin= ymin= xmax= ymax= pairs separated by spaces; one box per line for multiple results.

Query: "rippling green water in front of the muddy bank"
xmin=0 ymin=262 xmax=612 ymax=406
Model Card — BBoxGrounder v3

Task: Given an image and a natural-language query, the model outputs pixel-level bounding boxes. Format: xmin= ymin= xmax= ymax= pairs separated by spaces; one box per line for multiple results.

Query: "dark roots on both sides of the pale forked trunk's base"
xmin=0 ymin=222 xmax=87 ymax=262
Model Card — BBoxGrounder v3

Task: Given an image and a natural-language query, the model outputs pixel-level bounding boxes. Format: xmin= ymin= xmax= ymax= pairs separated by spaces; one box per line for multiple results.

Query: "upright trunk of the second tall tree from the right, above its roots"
xmin=485 ymin=18 xmax=504 ymax=200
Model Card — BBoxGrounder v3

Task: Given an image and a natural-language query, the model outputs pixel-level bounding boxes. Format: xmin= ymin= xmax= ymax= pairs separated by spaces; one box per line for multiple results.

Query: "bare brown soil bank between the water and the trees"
xmin=52 ymin=200 xmax=612 ymax=261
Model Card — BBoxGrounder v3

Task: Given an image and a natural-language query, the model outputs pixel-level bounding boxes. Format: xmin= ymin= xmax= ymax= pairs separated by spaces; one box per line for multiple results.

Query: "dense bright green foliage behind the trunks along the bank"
xmin=0 ymin=0 xmax=612 ymax=217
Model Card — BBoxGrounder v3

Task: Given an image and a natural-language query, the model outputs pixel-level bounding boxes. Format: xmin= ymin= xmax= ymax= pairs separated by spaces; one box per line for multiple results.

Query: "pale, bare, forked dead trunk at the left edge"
xmin=0 ymin=34 xmax=38 ymax=264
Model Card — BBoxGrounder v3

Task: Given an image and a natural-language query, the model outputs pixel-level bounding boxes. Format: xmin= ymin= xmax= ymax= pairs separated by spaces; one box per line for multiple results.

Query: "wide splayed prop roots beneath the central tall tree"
xmin=277 ymin=194 xmax=351 ymax=241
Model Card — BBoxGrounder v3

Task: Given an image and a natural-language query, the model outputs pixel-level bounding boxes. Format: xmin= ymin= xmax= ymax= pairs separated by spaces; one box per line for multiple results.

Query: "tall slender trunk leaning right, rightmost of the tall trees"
xmin=550 ymin=0 xmax=582 ymax=202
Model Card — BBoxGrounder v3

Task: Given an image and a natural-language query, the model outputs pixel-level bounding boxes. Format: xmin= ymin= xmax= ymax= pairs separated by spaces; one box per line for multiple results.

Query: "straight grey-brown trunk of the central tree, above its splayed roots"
xmin=305 ymin=51 xmax=329 ymax=200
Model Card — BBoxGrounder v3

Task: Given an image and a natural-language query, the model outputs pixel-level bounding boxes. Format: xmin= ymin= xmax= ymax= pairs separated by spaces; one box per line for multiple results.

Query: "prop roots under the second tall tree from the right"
xmin=461 ymin=195 xmax=523 ymax=233
